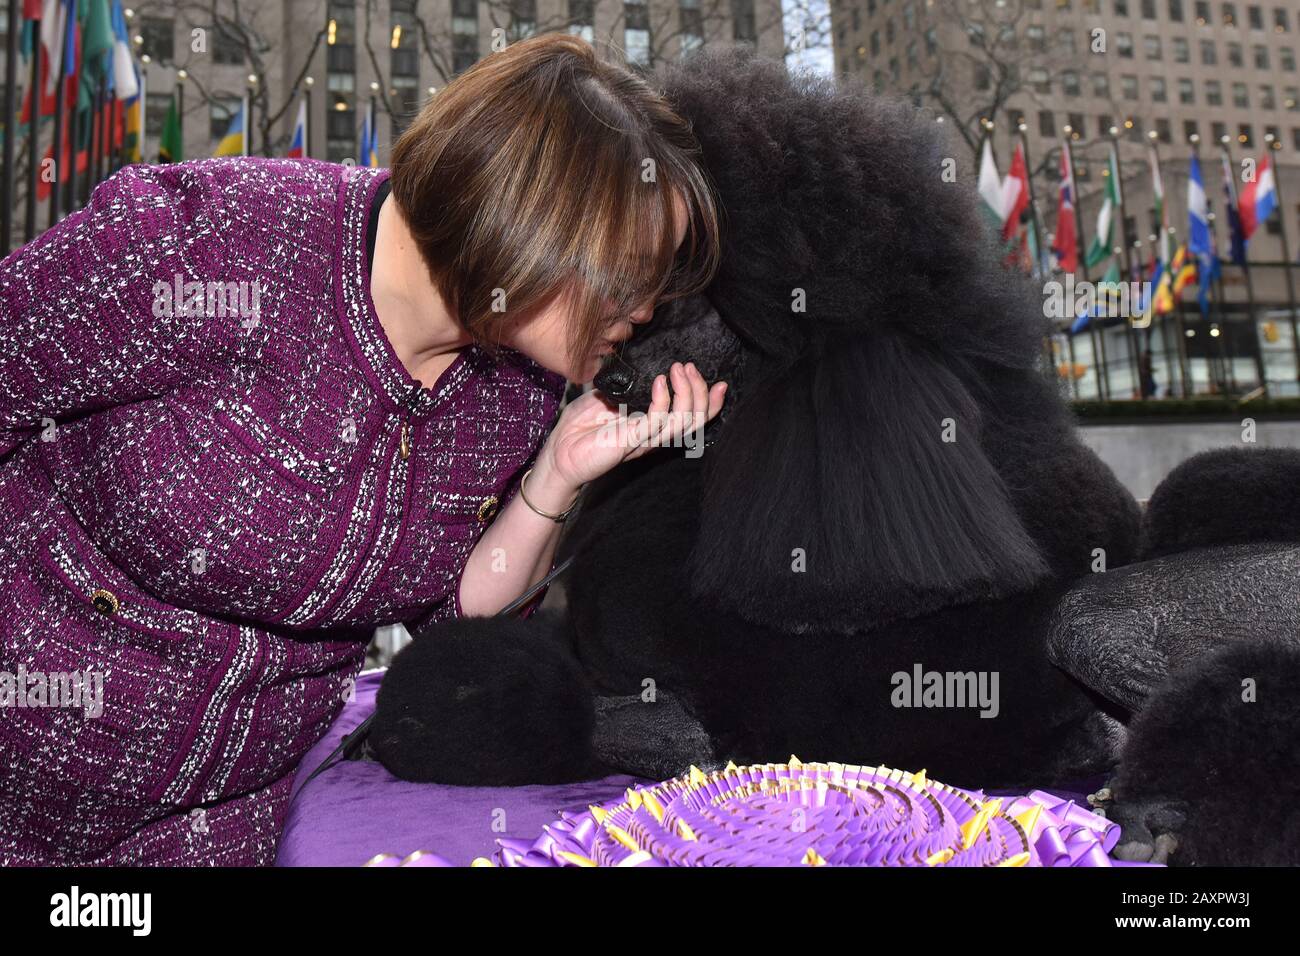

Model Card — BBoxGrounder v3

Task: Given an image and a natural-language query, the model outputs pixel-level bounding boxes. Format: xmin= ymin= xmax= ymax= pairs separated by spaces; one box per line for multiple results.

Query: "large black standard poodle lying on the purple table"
xmin=371 ymin=48 xmax=1300 ymax=861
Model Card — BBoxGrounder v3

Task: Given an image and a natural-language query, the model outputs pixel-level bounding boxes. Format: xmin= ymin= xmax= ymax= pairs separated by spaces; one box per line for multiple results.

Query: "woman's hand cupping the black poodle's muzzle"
xmin=528 ymin=362 xmax=727 ymax=511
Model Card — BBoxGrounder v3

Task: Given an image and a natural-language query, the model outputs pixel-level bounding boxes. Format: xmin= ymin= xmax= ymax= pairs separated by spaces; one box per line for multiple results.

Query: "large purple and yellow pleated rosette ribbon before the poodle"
xmin=476 ymin=757 xmax=1138 ymax=866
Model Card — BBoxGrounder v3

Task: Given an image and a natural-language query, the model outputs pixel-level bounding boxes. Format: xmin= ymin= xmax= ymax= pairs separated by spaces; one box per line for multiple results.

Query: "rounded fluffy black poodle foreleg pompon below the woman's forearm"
xmin=371 ymin=611 xmax=608 ymax=786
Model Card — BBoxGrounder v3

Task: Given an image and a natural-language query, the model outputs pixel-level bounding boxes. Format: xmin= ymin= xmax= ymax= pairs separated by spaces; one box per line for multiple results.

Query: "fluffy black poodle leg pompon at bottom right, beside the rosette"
xmin=1101 ymin=643 xmax=1300 ymax=866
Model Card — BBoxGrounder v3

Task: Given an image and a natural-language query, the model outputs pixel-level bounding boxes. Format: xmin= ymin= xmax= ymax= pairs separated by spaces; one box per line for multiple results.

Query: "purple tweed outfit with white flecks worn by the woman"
xmin=0 ymin=159 xmax=564 ymax=865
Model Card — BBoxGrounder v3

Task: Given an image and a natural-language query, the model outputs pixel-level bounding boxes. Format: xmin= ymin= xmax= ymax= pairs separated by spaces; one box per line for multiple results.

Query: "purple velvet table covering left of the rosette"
xmin=276 ymin=671 xmax=645 ymax=866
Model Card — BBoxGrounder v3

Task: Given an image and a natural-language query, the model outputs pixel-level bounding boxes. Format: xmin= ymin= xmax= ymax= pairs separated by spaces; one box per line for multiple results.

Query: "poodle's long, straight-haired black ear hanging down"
xmin=688 ymin=328 xmax=1049 ymax=632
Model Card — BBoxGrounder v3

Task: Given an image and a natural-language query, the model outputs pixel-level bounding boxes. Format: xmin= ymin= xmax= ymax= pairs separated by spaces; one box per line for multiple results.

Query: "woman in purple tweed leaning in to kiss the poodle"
xmin=0 ymin=35 xmax=724 ymax=865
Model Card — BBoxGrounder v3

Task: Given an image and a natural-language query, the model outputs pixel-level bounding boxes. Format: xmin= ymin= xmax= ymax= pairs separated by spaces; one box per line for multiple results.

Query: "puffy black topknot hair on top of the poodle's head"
xmin=662 ymin=46 xmax=1045 ymax=367
